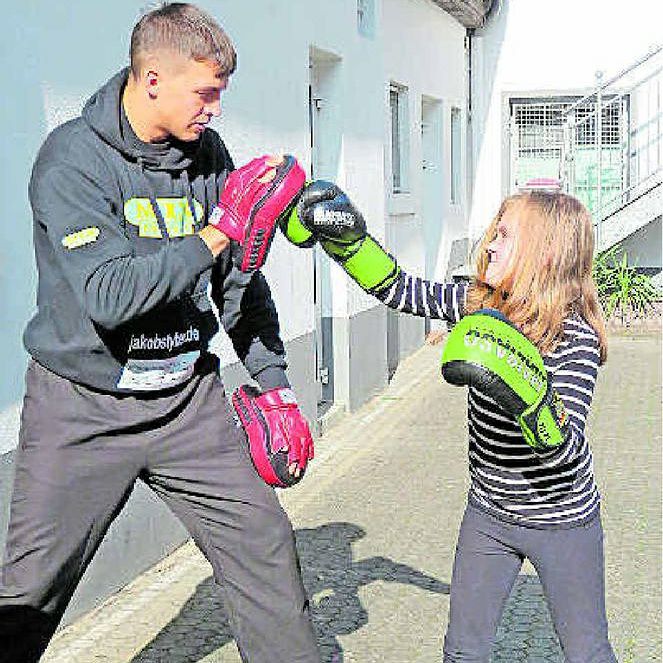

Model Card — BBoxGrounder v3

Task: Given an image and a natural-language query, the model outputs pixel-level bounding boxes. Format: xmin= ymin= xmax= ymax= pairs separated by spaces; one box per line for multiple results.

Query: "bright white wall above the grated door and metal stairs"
xmin=470 ymin=0 xmax=663 ymax=243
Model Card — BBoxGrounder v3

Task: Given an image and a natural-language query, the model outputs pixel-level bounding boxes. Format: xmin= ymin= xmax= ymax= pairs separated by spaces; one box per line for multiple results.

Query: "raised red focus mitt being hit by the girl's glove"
xmin=209 ymin=155 xmax=306 ymax=272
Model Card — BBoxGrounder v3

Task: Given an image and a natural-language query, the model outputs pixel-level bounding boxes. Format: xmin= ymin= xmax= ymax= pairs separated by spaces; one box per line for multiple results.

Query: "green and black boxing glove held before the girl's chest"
xmin=442 ymin=309 xmax=571 ymax=451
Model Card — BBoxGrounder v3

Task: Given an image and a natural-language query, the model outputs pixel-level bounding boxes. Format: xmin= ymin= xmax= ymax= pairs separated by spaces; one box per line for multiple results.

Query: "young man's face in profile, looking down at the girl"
xmin=148 ymin=54 xmax=228 ymax=141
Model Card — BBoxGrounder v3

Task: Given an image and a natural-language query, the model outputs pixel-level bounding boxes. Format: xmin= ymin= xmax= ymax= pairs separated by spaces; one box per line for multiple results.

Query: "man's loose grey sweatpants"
xmin=0 ymin=361 xmax=320 ymax=663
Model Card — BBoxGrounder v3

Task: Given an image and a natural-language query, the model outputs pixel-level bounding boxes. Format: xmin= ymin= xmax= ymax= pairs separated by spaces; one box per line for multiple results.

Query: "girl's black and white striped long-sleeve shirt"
xmin=380 ymin=272 xmax=600 ymax=528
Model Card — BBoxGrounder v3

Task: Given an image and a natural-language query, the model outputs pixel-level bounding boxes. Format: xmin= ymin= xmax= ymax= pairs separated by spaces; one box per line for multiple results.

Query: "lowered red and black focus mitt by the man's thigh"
xmin=232 ymin=385 xmax=313 ymax=488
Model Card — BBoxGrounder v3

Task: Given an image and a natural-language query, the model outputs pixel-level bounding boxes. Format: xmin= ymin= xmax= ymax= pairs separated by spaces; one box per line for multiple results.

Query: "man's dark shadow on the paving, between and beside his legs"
xmin=131 ymin=523 xmax=449 ymax=663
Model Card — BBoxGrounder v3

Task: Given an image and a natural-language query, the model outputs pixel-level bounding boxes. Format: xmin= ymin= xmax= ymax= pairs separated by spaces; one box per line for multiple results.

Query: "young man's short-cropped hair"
xmin=129 ymin=2 xmax=237 ymax=78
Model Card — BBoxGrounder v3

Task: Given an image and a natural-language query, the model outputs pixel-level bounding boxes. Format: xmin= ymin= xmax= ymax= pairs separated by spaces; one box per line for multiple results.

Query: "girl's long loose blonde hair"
xmin=465 ymin=192 xmax=607 ymax=363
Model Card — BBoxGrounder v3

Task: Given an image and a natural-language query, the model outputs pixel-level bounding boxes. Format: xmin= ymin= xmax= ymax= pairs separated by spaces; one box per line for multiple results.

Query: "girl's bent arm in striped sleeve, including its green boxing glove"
xmin=442 ymin=309 xmax=599 ymax=456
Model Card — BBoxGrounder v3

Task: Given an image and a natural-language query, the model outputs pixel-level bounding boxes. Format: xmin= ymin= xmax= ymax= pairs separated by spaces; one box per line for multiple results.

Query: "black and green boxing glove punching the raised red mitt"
xmin=281 ymin=180 xmax=401 ymax=297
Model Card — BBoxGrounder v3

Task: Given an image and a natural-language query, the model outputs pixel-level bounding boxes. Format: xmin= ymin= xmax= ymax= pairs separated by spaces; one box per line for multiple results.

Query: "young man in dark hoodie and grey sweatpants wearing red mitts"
xmin=0 ymin=3 xmax=319 ymax=663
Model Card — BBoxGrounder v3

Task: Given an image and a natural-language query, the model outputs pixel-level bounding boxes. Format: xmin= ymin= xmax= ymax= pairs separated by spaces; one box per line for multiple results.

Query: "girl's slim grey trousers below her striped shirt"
xmin=444 ymin=504 xmax=617 ymax=663
